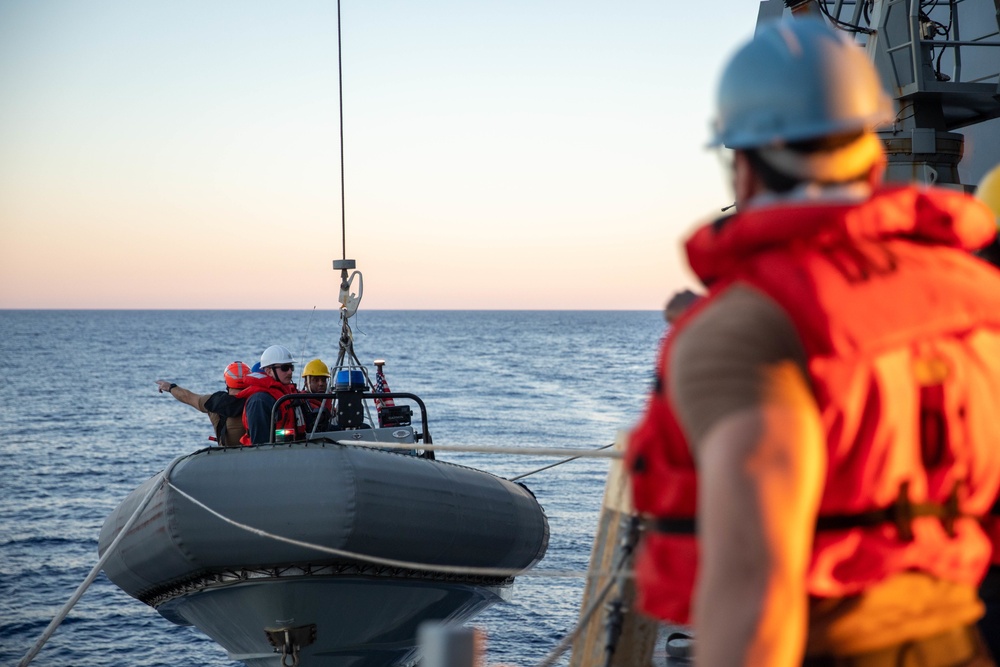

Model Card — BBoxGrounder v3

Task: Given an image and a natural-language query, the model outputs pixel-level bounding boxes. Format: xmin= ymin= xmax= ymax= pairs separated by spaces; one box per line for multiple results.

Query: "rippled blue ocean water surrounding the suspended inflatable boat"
xmin=0 ymin=310 xmax=664 ymax=667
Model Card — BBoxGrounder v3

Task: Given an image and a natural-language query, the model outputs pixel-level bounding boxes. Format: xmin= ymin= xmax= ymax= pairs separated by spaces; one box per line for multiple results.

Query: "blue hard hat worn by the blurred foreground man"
xmin=712 ymin=18 xmax=893 ymax=149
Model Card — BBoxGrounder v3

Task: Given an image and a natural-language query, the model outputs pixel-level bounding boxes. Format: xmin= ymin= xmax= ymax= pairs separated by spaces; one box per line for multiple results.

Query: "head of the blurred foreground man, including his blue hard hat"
xmin=712 ymin=19 xmax=893 ymax=210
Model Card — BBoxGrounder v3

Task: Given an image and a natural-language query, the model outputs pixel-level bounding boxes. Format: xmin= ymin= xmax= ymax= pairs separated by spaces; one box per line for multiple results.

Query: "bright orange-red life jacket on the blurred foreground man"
xmin=628 ymin=187 xmax=1000 ymax=623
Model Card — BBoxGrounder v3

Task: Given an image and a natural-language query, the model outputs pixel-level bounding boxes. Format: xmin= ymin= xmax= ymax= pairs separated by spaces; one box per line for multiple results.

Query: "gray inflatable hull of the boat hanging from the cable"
xmin=99 ymin=442 xmax=548 ymax=667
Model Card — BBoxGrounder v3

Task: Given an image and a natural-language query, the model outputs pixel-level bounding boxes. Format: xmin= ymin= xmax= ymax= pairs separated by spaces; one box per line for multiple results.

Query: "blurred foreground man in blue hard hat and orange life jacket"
xmin=627 ymin=19 xmax=1000 ymax=667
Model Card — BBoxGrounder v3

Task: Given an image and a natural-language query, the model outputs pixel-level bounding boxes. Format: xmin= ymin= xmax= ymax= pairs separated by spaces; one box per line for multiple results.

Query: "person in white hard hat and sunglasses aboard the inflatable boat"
xmin=239 ymin=345 xmax=305 ymax=445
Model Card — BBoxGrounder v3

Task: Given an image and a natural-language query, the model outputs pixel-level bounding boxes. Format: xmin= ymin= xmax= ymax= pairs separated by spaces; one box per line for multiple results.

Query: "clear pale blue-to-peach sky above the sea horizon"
xmin=0 ymin=0 xmax=758 ymax=310
